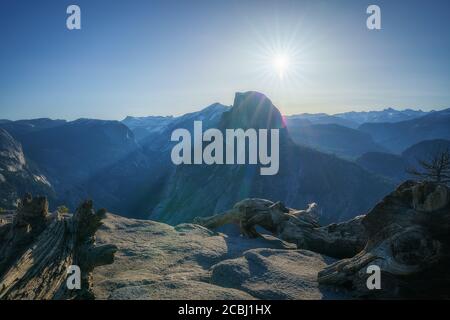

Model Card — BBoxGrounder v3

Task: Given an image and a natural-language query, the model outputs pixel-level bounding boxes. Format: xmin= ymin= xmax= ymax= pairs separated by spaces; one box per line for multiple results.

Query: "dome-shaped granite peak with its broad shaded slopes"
xmin=150 ymin=92 xmax=393 ymax=224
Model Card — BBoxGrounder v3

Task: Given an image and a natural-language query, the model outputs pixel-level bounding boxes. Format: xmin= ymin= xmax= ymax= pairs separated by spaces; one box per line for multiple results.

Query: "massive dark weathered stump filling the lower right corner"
xmin=318 ymin=181 xmax=450 ymax=299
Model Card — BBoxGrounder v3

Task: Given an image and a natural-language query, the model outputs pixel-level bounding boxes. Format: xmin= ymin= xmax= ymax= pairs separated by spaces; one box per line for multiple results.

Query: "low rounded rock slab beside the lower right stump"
xmin=211 ymin=249 xmax=345 ymax=300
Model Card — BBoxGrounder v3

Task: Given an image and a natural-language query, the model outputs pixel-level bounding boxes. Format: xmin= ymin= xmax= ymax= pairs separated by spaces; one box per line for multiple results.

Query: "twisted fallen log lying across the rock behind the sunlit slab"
xmin=194 ymin=199 xmax=367 ymax=258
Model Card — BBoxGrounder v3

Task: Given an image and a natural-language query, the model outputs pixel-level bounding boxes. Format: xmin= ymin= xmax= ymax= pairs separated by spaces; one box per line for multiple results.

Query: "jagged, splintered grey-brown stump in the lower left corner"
xmin=0 ymin=195 xmax=116 ymax=299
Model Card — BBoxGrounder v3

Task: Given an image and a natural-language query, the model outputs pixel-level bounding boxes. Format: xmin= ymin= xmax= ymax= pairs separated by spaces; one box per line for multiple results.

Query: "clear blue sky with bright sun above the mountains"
xmin=0 ymin=0 xmax=450 ymax=119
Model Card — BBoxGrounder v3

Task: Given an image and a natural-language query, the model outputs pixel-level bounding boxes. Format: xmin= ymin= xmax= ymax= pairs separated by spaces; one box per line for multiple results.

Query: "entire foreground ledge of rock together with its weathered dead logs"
xmin=0 ymin=181 xmax=450 ymax=299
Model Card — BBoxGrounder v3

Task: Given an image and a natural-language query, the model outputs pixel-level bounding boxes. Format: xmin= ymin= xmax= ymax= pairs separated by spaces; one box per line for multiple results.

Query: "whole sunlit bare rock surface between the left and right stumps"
xmin=93 ymin=214 xmax=344 ymax=299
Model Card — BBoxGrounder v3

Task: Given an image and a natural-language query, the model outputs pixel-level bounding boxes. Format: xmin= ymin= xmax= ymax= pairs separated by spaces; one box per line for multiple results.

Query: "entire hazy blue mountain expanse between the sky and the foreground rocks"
xmin=0 ymin=92 xmax=450 ymax=224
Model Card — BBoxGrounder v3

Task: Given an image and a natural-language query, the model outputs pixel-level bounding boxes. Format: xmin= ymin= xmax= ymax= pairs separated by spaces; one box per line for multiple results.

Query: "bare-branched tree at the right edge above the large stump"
xmin=406 ymin=149 xmax=450 ymax=184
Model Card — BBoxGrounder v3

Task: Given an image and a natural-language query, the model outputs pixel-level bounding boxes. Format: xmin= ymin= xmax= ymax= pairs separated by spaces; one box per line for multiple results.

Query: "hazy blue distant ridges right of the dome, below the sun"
xmin=286 ymin=108 xmax=450 ymax=160
